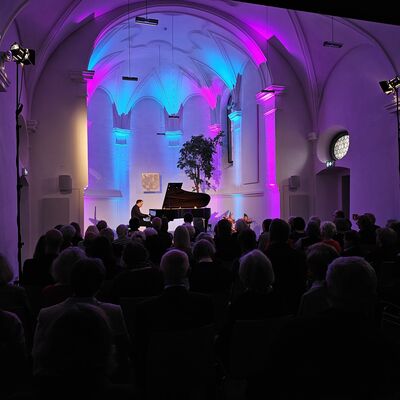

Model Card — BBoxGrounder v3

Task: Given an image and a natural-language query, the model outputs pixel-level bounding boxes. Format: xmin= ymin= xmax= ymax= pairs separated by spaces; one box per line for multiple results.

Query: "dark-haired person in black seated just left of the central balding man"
xmin=112 ymin=242 xmax=164 ymax=303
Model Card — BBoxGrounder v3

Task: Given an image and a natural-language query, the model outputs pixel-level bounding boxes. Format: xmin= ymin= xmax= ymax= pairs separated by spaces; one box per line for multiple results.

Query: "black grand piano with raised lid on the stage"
xmin=149 ymin=183 xmax=211 ymax=230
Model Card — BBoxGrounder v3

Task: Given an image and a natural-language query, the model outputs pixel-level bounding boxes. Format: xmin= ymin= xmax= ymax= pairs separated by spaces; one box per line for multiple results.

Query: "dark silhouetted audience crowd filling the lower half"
xmin=0 ymin=210 xmax=400 ymax=400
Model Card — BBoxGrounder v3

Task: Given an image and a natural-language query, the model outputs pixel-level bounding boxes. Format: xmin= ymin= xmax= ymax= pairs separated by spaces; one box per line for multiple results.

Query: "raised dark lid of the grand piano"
xmin=162 ymin=182 xmax=210 ymax=209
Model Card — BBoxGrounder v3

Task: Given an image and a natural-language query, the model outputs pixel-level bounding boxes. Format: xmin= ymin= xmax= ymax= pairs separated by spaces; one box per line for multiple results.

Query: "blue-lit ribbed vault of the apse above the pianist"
xmin=88 ymin=13 xmax=266 ymax=114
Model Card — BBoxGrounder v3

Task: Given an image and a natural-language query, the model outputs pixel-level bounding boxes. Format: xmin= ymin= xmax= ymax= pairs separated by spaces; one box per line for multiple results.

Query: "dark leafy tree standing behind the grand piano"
xmin=177 ymin=131 xmax=223 ymax=193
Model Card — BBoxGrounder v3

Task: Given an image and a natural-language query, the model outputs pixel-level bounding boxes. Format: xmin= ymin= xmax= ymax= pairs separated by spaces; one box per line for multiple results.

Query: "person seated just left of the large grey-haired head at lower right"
xmin=298 ymin=243 xmax=339 ymax=315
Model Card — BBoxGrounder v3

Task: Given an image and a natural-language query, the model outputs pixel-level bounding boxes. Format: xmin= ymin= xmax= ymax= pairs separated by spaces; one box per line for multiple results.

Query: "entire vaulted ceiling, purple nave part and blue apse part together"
xmin=0 ymin=0 xmax=400 ymax=115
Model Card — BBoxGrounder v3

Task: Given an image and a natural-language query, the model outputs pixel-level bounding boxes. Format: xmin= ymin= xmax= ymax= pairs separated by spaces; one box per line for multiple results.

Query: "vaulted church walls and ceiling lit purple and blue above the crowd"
xmin=0 ymin=0 xmax=400 ymax=399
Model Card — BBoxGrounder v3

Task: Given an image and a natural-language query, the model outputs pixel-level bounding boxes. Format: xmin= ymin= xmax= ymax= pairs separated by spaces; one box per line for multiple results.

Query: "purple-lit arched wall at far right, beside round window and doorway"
xmin=317 ymin=46 xmax=400 ymax=225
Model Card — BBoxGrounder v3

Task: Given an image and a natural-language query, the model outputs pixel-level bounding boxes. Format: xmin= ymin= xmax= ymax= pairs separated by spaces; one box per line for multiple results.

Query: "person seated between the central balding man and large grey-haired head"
xmin=189 ymin=239 xmax=232 ymax=293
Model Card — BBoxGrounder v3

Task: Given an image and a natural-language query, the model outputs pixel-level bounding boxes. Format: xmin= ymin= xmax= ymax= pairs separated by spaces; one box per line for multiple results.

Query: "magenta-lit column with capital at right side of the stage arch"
xmin=256 ymin=85 xmax=284 ymax=218
